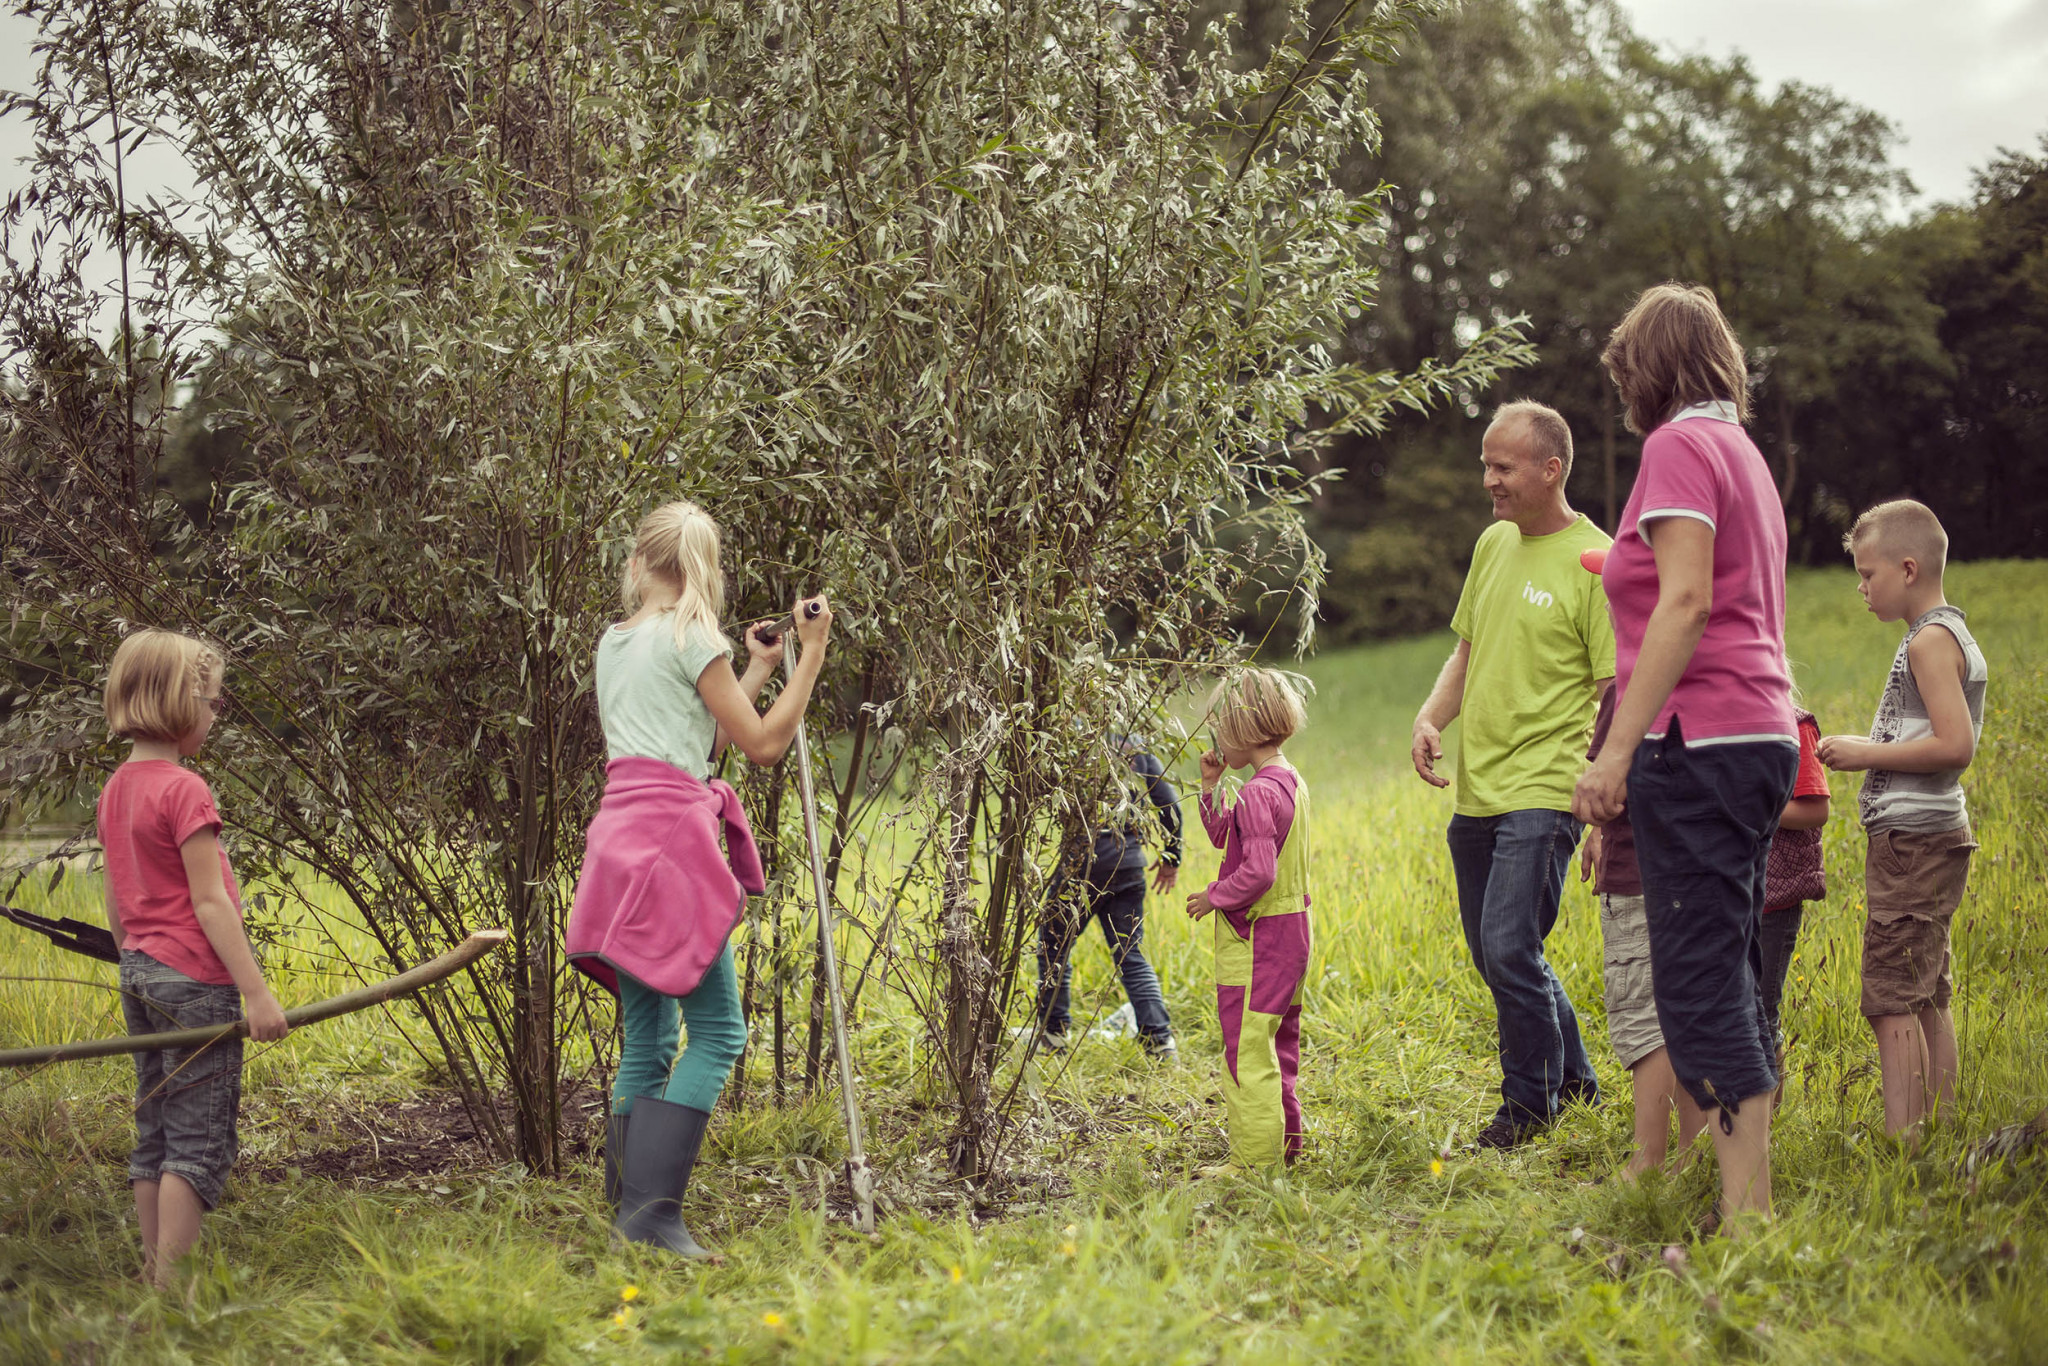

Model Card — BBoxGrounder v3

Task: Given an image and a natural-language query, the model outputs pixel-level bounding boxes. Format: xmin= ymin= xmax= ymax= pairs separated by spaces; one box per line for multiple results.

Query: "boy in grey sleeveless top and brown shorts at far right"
xmin=1821 ymin=498 xmax=1989 ymax=1143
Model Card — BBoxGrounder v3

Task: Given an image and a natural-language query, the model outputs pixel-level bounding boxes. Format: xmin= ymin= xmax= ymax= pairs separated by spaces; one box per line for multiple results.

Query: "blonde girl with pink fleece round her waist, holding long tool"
xmin=567 ymin=502 xmax=831 ymax=1260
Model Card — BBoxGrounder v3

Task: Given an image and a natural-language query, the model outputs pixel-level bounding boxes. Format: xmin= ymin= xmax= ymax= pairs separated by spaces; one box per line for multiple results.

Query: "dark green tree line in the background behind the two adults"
xmin=1220 ymin=0 xmax=2048 ymax=639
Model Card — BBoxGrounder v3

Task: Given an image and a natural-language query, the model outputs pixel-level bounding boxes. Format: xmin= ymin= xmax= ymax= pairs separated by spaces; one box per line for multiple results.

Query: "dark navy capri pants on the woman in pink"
xmin=1628 ymin=717 xmax=1798 ymax=1133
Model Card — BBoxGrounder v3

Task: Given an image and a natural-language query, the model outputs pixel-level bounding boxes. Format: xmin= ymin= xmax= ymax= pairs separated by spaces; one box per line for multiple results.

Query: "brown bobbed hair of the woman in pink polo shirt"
xmin=1599 ymin=281 xmax=1749 ymax=436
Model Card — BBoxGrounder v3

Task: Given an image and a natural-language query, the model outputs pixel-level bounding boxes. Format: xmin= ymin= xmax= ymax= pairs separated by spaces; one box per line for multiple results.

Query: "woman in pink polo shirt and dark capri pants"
xmin=1573 ymin=285 xmax=1798 ymax=1231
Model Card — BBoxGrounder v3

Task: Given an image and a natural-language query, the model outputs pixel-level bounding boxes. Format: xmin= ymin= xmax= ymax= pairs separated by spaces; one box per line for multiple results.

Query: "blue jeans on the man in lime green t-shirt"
xmin=1448 ymin=811 xmax=1599 ymax=1124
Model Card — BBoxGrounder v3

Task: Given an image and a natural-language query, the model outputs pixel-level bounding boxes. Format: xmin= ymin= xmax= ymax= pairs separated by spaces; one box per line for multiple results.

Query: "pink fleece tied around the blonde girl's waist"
xmin=567 ymin=758 xmax=768 ymax=995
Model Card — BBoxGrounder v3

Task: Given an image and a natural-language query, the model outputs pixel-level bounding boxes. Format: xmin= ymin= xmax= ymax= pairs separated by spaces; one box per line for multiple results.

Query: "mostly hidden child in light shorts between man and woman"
xmin=1579 ymin=688 xmax=1706 ymax=1182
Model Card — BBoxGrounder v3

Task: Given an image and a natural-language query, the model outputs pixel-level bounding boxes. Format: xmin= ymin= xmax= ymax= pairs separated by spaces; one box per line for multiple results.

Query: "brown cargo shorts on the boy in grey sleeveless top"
xmin=1862 ymin=825 xmax=1976 ymax=1020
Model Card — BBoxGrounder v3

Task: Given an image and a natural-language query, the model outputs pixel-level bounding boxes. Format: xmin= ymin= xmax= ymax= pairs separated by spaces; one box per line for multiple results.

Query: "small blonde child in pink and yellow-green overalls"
xmin=1188 ymin=670 xmax=1311 ymax=1176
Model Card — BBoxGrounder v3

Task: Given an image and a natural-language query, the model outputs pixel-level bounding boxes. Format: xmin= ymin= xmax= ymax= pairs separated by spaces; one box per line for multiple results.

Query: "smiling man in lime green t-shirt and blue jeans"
xmin=1411 ymin=403 xmax=1614 ymax=1147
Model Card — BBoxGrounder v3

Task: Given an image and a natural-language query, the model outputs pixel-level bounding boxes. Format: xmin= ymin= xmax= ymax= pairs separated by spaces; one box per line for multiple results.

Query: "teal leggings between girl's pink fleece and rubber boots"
xmin=612 ymin=944 xmax=748 ymax=1114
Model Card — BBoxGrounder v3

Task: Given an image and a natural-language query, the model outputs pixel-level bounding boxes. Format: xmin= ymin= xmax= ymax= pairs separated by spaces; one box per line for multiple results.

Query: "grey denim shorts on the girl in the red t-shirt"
xmin=121 ymin=948 xmax=242 ymax=1210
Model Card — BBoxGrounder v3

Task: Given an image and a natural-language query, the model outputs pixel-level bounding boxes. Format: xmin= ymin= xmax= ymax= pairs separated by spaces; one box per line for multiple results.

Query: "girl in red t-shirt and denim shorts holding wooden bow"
xmin=98 ymin=631 xmax=291 ymax=1286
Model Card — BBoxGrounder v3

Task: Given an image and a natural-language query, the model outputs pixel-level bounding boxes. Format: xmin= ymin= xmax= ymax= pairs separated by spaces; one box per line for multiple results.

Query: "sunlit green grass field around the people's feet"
xmin=0 ymin=563 xmax=2048 ymax=1364
